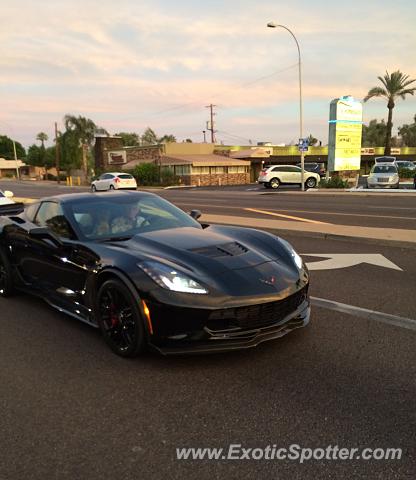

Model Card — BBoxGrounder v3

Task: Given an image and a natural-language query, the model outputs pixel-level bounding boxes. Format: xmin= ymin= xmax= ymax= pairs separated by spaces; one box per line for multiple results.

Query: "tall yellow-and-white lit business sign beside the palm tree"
xmin=328 ymin=95 xmax=363 ymax=172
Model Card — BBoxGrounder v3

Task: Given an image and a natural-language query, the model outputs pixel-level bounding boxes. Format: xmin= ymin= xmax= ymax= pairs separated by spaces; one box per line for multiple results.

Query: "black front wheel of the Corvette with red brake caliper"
xmin=95 ymin=278 xmax=146 ymax=358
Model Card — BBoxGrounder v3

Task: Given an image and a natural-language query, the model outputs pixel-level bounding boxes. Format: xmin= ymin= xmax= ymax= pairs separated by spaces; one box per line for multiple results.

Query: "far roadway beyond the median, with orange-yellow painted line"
xmin=0 ymin=182 xmax=416 ymax=230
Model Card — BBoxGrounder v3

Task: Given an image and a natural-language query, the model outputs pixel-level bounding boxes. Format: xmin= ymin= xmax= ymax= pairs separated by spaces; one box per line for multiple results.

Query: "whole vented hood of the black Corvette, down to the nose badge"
xmin=101 ymin=227 xmax=301 ymax=296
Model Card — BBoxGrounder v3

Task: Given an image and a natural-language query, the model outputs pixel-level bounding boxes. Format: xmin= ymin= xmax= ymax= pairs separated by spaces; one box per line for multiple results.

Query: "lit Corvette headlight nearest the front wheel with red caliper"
xmin=137 ymin=260 xmax=208 ymax=294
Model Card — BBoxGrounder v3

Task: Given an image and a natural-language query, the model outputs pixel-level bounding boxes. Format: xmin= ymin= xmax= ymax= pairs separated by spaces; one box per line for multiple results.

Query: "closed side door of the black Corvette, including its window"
xmin=19 ymin=201 xmax=97 ymax=317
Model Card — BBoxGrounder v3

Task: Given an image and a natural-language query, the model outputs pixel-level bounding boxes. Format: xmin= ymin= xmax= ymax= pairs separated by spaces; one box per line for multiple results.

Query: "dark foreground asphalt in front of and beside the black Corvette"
xmin=0 ymin=236 xmax=416 ymax=480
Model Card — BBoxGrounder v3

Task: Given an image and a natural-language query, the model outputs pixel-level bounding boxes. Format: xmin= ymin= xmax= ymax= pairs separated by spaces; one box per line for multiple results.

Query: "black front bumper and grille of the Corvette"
xmin=145 ymin=287 xmax=310 ymax=355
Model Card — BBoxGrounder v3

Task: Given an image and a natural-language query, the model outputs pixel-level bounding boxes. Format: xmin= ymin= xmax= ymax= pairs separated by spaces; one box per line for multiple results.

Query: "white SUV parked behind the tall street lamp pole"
xmin=257 ymin=165 xmax=321 ymax=189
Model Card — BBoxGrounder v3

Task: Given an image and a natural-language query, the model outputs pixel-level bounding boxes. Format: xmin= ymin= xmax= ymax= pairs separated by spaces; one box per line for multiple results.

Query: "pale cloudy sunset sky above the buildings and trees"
xmin=0 ymin=0 xmax=416 ymax=147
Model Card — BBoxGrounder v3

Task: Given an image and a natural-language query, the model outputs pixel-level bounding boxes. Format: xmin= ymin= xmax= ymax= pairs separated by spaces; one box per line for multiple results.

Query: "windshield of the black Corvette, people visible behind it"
xmin=65 ymin=195 xmax=202 ymax=241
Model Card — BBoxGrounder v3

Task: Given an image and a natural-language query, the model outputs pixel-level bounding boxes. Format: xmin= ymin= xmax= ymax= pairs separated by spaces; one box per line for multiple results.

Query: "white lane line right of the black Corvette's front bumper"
xmin=310 ymin=297 xmax=416 ymax=330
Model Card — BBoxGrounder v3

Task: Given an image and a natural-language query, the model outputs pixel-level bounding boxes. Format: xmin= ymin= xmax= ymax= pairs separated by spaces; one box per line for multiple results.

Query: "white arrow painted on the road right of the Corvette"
xmin=302 ymin=253 xmax=403 ymax=272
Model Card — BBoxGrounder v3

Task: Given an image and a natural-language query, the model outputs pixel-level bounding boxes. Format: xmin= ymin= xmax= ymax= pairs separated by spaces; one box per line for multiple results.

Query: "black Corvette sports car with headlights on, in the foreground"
xmin=0 ymin=192 xmax=310 ymax=357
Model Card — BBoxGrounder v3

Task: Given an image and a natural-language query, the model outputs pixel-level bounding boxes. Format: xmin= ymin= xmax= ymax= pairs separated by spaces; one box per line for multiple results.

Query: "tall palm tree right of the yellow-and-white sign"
xmin=364 ymin=70 xmax=416 ymax=155
